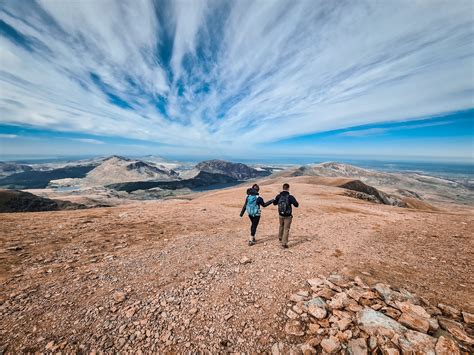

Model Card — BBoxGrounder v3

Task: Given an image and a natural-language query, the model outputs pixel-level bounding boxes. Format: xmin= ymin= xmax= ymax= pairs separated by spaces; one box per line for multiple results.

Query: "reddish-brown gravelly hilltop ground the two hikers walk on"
xmin=0 ymin=177 xmax=474 ymax=353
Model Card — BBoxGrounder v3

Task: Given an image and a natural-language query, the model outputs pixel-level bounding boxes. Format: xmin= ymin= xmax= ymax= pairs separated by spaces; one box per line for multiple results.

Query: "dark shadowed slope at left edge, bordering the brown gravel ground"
xmin=0 ymin=190 xmax=85 ymax=213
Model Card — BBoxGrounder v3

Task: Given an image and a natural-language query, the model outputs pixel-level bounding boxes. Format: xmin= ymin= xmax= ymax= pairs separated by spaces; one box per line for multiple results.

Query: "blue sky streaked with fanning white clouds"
xmin=0 ymin=0 xmax=474 ymax=161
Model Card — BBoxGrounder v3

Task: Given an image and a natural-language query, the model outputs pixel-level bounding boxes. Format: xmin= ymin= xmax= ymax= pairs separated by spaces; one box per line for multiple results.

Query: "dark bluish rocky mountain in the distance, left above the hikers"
xmin=196 ymin=160 xmax=270 ymax=180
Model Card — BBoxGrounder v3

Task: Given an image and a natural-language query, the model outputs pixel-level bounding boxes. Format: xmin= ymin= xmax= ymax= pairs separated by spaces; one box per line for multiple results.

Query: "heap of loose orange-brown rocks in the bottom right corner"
xmin=272 ymin=274 xmax=474 ymax=355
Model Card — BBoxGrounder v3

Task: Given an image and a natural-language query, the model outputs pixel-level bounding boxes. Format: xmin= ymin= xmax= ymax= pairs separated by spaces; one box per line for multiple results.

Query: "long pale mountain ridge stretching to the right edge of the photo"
xmin=276 ymin=162 xmax=474 ymax=204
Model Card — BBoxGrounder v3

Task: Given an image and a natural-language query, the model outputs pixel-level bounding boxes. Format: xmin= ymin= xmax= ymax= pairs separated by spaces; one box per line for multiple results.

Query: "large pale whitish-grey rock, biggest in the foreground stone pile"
xmin=357 ymin=308 xmax=407 ymax=338
